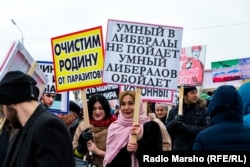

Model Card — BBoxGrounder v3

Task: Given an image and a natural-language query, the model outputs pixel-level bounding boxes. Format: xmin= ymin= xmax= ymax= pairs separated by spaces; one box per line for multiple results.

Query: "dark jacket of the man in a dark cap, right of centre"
xmin=166 ymin=99 xmax=208 ymax=151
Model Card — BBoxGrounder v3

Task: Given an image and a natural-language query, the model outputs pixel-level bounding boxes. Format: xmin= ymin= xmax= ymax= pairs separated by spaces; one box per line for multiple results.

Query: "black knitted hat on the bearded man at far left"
xmin=0 ymin=71 xmax=39 ymax=105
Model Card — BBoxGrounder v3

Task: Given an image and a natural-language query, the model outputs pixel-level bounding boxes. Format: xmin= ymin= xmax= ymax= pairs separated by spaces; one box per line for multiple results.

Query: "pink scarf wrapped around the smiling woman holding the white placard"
xmin=104 ymin=103 xmax=149 ymax=167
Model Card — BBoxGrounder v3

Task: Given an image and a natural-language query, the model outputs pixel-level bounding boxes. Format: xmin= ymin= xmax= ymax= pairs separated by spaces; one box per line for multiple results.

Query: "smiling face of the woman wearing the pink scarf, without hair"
xmin=120 ymin=95 xmax=135 ymax=118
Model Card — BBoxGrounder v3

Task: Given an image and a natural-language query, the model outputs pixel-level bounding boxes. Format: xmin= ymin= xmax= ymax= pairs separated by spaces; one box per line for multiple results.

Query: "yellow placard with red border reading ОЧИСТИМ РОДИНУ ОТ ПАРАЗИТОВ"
xmin=51 ymin=26 xmax=104 ymax=92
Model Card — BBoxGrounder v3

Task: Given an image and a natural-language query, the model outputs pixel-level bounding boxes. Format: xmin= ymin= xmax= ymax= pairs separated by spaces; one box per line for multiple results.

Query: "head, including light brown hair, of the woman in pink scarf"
xmin=119 ymin=91 xmax=135 ymax=118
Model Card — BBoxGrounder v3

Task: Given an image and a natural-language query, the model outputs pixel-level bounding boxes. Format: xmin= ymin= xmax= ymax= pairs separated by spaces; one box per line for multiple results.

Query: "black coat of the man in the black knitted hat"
xmin=4 ymin=104 xmax=75 ymax=167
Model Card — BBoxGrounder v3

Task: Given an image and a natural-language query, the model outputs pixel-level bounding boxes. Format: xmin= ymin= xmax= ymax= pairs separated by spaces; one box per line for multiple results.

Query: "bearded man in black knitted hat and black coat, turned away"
xmin=0 ymin=71 xmax=75 ymax=167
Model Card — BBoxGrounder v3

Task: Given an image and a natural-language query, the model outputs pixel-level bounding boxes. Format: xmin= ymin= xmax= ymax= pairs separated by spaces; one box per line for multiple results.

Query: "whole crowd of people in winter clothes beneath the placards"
xmin=0 ymin=71 xmax=250 ymax=167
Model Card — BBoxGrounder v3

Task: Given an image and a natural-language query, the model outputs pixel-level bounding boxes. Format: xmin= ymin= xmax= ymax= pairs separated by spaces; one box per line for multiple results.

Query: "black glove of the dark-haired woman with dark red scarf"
xmin=77 ymin=128 xmax=93 ymax=154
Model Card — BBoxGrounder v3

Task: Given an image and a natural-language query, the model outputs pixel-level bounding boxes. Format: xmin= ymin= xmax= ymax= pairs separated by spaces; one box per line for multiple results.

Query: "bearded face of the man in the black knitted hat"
xmin=1 ymin=105 xmax=22 ymax=129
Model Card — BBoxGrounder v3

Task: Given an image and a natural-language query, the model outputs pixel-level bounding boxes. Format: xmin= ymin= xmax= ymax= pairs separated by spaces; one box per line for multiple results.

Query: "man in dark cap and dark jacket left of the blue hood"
xmin=166 ymin=86 xmax=209 ymax=151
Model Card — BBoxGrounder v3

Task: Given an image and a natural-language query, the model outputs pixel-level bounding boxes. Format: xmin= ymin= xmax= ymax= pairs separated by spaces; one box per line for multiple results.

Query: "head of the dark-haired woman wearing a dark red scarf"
xmin=88 ymin=94 xmax=111 ymax=121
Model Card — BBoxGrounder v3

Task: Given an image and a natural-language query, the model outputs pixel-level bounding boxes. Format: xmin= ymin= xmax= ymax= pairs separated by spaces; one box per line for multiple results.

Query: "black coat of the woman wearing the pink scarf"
xmin=107 ymin=121 xmax=162 ymax=167
